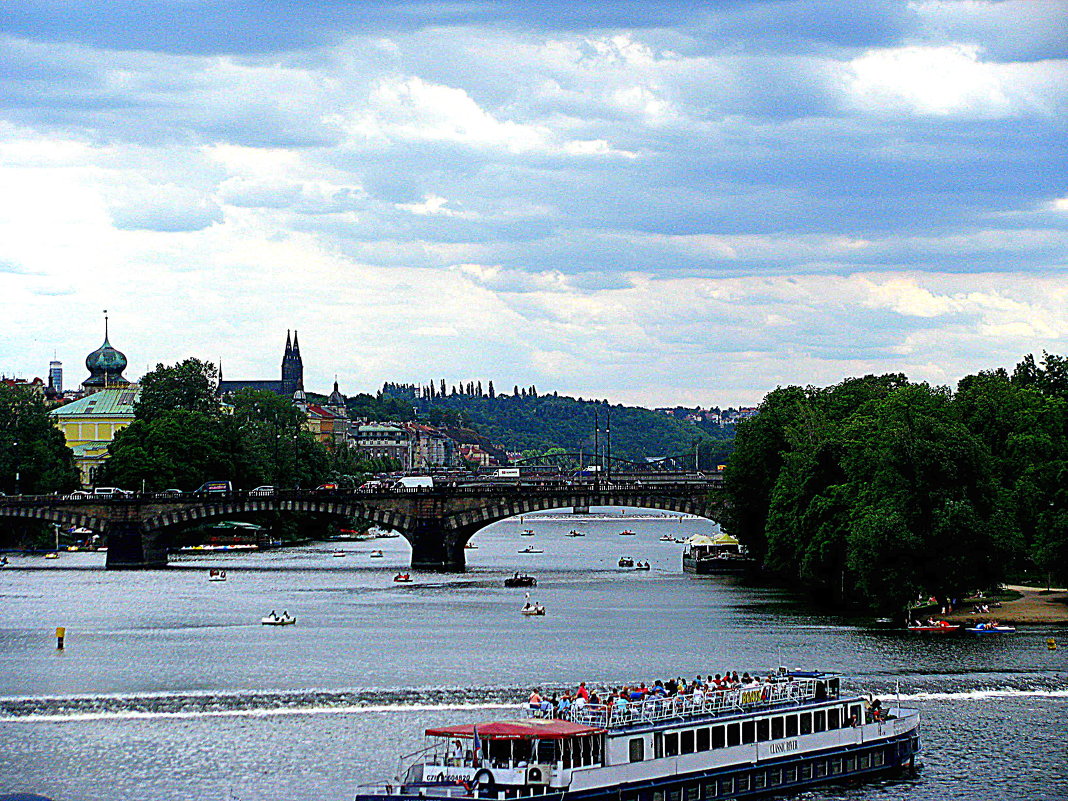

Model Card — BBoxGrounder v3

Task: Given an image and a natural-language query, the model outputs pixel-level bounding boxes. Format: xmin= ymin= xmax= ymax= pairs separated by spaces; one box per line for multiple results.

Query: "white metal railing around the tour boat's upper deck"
xmin=555 ymin=678 xmax=829 ymax=728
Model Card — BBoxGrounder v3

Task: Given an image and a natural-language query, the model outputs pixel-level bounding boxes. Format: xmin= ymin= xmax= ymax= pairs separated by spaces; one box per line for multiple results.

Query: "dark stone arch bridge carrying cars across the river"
xmin=0 ymin=476 xmax=720 ymax=570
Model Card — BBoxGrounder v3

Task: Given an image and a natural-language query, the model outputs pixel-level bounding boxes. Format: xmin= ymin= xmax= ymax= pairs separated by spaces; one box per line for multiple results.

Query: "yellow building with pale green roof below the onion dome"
xmin=49 ymin=384 xmax=141 ymax=487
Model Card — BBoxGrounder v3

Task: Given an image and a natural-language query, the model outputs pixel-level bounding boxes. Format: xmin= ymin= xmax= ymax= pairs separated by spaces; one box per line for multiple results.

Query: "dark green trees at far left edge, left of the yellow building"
xmin=0 ymin=386 xmax=78 ymax=494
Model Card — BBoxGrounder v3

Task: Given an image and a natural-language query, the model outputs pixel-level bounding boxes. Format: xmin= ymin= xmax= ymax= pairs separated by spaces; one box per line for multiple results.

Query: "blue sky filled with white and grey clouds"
xmin=0 ymin=0 xmax=1068 ymax=407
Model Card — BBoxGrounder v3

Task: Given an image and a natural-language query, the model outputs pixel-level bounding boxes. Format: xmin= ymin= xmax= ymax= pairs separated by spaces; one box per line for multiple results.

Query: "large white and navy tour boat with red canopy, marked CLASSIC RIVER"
xmin=356 ymin=669 xmax=920 ymax=801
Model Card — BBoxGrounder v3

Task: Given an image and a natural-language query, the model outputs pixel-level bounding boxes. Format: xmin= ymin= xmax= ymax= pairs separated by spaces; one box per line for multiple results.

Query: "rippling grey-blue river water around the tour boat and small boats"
xmin=0 ymin=511 xmax=1068 ymax=801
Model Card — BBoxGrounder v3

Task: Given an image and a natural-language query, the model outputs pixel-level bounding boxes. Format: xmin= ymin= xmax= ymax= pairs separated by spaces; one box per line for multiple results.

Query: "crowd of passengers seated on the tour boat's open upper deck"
xmin=528 ymin=671 xmax=824 ymax=719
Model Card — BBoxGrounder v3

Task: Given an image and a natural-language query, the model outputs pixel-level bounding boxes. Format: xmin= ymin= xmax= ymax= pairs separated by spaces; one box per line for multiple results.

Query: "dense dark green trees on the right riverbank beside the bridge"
xmin=721 ymin=355 xmax=1068 ymax=610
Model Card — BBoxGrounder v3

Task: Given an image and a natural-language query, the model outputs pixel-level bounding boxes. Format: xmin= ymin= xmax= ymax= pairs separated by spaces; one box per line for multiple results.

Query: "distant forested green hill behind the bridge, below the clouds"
xmin=349 ymin=383 xmax=733 ymax=469
